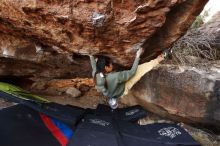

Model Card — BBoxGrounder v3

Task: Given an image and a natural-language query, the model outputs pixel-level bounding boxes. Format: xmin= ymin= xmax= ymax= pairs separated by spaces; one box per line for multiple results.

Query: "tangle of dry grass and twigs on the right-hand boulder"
xmin=172 ymin=29 xmax=217 ymax=65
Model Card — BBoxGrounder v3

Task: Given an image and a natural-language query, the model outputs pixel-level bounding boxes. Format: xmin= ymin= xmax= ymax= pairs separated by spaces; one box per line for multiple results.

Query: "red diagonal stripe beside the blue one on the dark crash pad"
xmin=39 ymin=113 xmax=68 ymax=146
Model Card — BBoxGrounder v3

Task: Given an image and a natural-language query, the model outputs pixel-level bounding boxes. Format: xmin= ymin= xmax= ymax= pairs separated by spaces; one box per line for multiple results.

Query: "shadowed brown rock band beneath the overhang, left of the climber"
xmin=0 ymin=33 xmax=90 ymax=78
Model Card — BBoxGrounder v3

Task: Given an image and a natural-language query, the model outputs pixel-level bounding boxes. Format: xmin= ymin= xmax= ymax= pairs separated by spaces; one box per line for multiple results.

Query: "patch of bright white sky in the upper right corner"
xmin=202 ymin=0 xmax=220 ymax=22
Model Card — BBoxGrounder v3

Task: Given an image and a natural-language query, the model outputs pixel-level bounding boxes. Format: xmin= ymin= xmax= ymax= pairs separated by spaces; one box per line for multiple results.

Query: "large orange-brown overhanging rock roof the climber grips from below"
xmin=0 ymin=0 xmax=208 ymax=68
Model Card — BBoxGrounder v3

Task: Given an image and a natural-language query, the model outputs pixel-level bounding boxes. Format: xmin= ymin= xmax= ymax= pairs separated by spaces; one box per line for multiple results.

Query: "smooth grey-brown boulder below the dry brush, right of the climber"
xmin=122 ymin=62 xmax=220 ymax=126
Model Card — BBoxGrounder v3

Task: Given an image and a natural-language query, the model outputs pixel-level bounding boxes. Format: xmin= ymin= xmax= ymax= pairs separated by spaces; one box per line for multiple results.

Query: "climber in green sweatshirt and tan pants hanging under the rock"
xmin=89 ymin=48 xmax=168 ymax=109
